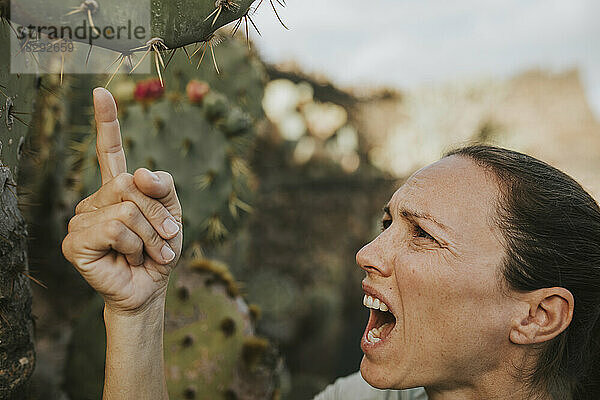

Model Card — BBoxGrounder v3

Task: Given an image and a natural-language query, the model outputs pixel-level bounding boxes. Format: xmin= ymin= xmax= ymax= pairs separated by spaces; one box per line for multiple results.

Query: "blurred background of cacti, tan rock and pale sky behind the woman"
xmin=5 ymin=0 xmax=600 ymax=400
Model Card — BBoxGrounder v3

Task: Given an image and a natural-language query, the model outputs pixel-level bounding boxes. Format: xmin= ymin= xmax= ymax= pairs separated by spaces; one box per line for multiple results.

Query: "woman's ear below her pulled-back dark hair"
xmin=510 ymin=287 xmax=575 ymax=344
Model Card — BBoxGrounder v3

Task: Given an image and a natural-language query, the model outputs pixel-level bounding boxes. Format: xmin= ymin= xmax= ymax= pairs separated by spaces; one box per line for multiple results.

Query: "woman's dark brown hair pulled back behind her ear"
xmin=446 ymin=145 xmax=600 ymax=400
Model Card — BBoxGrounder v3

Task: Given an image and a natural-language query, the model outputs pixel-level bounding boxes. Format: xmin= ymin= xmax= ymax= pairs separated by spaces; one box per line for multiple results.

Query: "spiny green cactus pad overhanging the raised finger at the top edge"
xmin=0 ymin=0 xmax=254 ymax=54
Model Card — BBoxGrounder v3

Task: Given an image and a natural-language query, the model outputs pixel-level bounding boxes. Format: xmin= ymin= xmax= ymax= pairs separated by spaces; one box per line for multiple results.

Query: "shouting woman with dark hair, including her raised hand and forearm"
xmin=63 ymin=90 xmax=600 ymax=400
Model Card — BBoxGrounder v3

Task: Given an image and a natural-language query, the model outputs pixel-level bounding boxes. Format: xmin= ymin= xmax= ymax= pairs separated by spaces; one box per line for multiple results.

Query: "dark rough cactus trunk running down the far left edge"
xmin=0 ymin=20 xmax=36 ymax=399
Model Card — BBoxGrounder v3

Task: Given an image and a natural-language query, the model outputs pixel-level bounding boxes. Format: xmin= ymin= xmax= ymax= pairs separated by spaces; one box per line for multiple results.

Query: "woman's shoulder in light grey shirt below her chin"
xmin=313 ymin=372 xmax=427 ymax=400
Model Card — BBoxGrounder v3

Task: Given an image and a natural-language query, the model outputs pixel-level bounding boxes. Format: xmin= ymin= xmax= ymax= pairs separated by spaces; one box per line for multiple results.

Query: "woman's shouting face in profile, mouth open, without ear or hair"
xmin=356 ymin=156 xmax=515 ymax=388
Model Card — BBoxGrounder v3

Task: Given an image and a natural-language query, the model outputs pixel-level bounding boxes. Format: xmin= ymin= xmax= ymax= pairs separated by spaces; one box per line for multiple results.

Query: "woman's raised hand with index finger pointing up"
xmin=62 ymin=88 xmax=183 ymax=313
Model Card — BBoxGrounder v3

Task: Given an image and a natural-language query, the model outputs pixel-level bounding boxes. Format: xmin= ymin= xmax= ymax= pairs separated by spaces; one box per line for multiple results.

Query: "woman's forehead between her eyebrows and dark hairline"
xmin=389 ymin=156 xmax=498 ymax=238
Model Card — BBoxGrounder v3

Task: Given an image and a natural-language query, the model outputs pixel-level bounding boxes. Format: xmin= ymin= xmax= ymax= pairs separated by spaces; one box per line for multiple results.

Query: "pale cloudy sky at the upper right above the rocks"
xmin=251 ymin=0 xmax=600 ymax=118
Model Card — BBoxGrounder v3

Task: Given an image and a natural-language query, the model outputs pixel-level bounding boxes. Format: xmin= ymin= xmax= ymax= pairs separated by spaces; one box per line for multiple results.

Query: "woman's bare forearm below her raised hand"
xmin=103 ymin=296 xmax=169 ymax=400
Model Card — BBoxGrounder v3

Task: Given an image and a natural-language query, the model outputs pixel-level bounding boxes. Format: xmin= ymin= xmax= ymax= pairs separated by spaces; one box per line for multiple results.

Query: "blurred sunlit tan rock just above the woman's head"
xmin=358 ymin=70 xmax=600 ymax=198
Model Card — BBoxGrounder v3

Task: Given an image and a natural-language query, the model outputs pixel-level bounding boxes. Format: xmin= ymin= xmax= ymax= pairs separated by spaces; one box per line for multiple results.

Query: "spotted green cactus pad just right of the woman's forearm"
xmin=165 ymin=259 xmax=278 ymax=400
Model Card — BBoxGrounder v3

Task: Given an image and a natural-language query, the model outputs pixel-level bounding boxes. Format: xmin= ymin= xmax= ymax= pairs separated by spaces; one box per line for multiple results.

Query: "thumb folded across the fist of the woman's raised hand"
xmin=133 ymin=168 xmax=182 ymax=223
